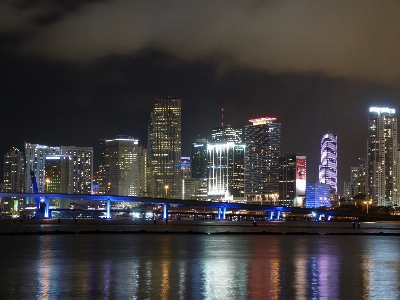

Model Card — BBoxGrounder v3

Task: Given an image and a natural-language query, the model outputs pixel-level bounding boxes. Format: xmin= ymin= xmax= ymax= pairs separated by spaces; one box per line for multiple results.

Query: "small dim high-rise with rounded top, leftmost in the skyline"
xmin=3 ymin=148 xmax=25 ymax=193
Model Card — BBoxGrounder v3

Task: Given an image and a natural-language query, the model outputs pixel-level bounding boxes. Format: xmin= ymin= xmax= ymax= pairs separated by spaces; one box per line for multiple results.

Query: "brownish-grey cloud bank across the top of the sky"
xmin=0 ymin=0 xmax=400 ymax=84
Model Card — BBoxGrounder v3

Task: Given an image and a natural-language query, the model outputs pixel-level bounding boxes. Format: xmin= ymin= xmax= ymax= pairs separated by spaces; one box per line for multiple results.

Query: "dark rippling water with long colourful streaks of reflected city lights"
xmin=0 ymin=234 xmax=400 ymax=300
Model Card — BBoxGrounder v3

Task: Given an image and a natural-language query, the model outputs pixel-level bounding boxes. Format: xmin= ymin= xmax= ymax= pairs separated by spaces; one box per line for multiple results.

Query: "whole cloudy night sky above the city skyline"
xmin=0 ymin=0 xmax=400 ymax=192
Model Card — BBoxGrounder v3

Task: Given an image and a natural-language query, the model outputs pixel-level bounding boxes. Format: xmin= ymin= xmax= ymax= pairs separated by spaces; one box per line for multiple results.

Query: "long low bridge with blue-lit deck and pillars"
xmin=0 ymin=192 xmax=400 ymax=221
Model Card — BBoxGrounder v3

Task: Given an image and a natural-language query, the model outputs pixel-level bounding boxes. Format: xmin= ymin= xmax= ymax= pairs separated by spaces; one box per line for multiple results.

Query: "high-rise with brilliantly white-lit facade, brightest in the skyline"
xmin=207 ymin=142 xmax=246 ymax=201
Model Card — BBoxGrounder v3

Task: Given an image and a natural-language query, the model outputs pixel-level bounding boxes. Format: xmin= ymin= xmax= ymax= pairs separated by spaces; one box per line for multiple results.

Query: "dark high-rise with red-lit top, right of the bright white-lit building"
xmin=245 ymin=118 xmax=281 ymax=203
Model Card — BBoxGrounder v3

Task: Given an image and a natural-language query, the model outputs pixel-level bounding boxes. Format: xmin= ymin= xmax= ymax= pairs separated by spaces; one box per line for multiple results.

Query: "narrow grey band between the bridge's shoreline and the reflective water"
xmin=0 ymin=219 xmax=400 ymax=236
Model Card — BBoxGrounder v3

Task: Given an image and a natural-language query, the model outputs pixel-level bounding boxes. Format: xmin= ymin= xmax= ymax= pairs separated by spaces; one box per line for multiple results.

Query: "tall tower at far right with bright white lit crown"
xmin=367 ymin=107 xmax=400 ymax=206
